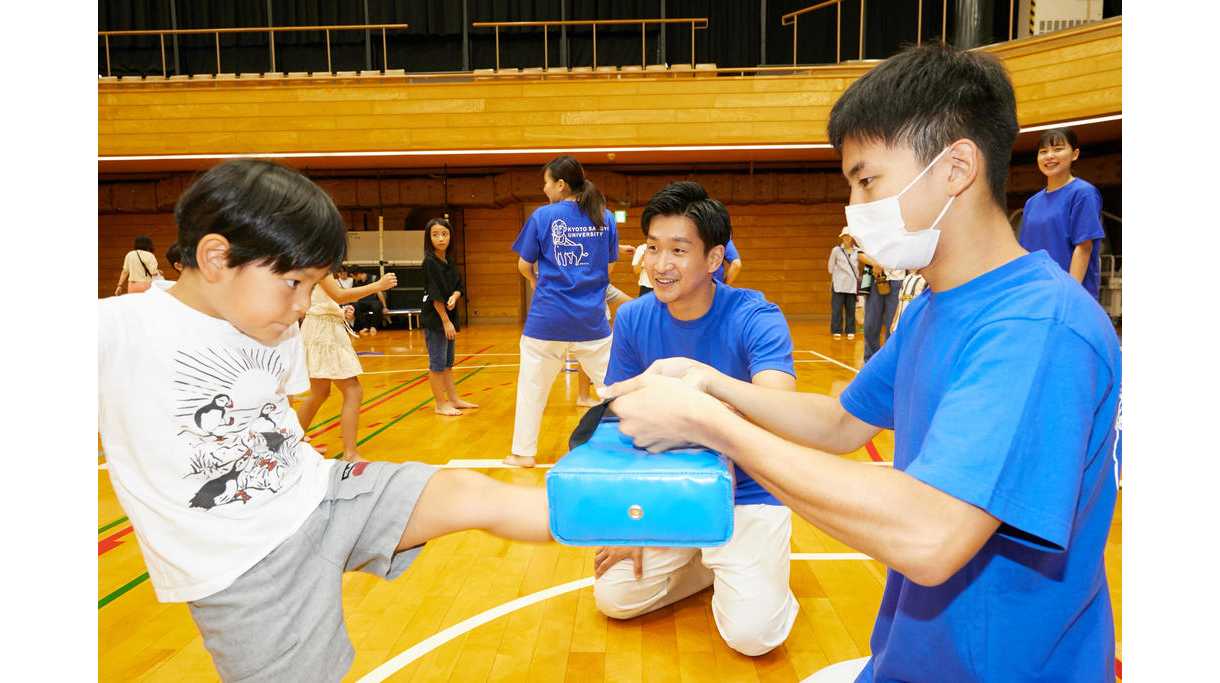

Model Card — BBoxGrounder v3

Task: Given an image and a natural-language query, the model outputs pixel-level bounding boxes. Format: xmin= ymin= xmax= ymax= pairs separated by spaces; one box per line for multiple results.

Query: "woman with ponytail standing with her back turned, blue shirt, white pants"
xmin=504 ymin=155 xmax=619 ymax=467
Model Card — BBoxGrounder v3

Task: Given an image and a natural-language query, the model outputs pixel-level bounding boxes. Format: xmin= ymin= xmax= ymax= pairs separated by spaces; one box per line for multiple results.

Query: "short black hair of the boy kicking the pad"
xmin=173 ymin=159 xmax=348 ymax=273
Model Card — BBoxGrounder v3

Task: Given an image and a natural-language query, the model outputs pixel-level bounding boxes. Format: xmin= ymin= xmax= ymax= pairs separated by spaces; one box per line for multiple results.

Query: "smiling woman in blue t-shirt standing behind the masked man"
xmin=1020 ymin=128 xmax=1105 ymax=299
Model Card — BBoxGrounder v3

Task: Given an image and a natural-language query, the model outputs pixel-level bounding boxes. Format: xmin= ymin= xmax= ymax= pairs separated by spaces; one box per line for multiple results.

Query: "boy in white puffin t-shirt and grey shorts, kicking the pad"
xmin=98 ymin=160 xmax=550 ymax=681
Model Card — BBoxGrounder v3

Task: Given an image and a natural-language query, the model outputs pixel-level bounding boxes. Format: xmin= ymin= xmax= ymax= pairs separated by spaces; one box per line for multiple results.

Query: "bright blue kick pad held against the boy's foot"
xmin=547 ymin=421 xmax=733 ymax=548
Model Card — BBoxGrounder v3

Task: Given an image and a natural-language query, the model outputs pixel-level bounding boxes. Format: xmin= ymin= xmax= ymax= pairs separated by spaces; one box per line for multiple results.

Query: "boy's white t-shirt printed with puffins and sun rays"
xmin=98 ymin=287 xmax=333 ymax=603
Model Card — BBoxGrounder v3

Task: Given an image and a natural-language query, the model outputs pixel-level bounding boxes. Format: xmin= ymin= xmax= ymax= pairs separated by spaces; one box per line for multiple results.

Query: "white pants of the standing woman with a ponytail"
xmin=512 ymin=334 xmax=611 ymax=457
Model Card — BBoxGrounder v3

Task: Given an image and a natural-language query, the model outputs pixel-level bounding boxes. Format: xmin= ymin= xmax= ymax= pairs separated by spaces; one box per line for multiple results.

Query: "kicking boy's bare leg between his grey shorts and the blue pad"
xmin=398 ymin=470 xmax=550 ymax=550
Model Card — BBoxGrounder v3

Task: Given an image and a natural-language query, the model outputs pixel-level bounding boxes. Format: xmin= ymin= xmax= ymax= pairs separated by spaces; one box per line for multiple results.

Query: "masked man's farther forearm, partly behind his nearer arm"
xmin=708 ymin=374 xmax=878 ymax=454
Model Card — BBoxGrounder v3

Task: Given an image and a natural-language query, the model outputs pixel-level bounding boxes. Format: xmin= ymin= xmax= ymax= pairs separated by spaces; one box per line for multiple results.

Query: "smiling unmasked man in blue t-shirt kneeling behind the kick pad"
xmin=593 ymin=182 xmax=799 ymax=656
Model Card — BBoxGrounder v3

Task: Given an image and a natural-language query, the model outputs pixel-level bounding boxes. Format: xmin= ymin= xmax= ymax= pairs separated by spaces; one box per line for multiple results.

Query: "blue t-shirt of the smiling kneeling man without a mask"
xmin=606 ymin=283 xmax=797 ymax=505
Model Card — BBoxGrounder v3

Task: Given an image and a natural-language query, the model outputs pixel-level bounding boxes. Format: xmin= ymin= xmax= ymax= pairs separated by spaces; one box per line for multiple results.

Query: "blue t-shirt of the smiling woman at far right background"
xmin=1020 ymin=178 xmax=1105 ymax=299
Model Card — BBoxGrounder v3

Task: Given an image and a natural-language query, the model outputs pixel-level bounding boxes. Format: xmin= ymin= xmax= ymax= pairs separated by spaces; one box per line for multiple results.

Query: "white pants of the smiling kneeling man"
xmin=593 ymin=505 xmax=800 ymax=656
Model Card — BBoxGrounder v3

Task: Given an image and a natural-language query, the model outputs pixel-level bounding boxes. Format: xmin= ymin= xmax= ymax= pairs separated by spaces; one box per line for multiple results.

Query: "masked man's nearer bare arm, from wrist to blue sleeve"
xmin=694 ymin=414 xmax=999 ymax=585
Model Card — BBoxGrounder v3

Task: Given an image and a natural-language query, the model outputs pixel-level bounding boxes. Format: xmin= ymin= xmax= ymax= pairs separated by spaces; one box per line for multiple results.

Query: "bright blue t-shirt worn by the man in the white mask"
xmin=839 ymin=252 xmax=1120 ymax=682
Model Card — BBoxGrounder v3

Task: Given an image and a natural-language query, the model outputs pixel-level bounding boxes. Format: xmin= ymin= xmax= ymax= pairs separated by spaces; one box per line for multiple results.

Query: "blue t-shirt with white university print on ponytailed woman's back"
xmin=512 ymin=200 xmax=619 ymax=342
